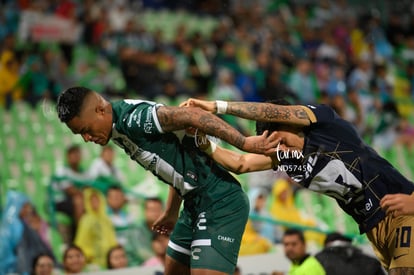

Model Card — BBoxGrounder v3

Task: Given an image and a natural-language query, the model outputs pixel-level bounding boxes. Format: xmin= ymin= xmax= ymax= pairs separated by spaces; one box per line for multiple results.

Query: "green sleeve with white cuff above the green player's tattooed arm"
xmin=123 ymin=102 xmax=164 ymax=135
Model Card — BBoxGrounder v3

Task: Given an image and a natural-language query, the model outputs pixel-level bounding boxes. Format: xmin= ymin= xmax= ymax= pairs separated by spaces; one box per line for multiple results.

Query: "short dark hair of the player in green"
xmin=56 ymin=87 xmax=92 ymax=123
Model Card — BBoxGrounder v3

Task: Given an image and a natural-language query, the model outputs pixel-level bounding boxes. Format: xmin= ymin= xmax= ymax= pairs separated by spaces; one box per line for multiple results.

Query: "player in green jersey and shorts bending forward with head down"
xmin=57 ymin=87 xmax=276 ymax=275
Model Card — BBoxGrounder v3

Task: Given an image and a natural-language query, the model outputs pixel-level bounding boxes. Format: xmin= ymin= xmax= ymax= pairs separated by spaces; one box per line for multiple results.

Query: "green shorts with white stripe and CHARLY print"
xmin=167 ymin=187 xmax=249 ymax=274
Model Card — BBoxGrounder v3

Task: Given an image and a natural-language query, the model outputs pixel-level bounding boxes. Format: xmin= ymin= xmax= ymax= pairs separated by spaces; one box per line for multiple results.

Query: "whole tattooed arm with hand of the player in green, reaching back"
xmin=157 ymin=106 xmax=276 ymax=154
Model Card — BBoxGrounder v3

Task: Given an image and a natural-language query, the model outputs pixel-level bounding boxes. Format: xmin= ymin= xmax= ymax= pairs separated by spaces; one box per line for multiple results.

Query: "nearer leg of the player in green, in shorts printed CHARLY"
xmin=191 ymin=189 xmax=249 ymax=275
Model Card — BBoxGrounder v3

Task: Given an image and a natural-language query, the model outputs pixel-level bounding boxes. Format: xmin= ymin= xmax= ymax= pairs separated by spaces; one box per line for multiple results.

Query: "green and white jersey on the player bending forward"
xmin=112 ymin=100 xmax=239 ymax=199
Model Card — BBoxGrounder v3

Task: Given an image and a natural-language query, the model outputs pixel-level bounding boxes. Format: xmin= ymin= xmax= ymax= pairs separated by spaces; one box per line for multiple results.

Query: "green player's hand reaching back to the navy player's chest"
xmin=243 ymin=130 xmax=281 ymax=155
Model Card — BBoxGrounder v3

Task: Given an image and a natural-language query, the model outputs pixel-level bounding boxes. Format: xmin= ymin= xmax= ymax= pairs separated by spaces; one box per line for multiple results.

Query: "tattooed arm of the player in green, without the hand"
xmin=157 ymin=106 xmax=246 ymax=149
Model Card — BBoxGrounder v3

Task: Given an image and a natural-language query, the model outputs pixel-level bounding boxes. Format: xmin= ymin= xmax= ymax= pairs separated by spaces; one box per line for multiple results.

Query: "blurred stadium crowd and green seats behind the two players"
xmin=0 ymin=0 xmax=414 ymax=274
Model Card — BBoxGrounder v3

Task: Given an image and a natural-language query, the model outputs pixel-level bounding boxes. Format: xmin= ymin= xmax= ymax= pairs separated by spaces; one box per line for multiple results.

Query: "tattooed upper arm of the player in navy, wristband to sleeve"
xmin=227 ymin=102 xmax=310 ymax=125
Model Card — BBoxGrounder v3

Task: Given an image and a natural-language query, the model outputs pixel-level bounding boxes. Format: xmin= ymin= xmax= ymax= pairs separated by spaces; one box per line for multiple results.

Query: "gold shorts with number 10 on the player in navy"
xmin=367 ymin=215 xmax=414 ymax=270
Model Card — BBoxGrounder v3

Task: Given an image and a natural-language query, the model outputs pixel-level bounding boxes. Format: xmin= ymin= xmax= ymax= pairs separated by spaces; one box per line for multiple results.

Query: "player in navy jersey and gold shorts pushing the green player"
xmin=181 ymin=99 xmax=414 ymax=274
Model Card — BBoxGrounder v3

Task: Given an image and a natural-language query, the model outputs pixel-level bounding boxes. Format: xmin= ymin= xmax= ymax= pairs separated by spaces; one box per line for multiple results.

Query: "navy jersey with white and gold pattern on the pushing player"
xmin=280 ymin=105 xmax=414 ymax=234
